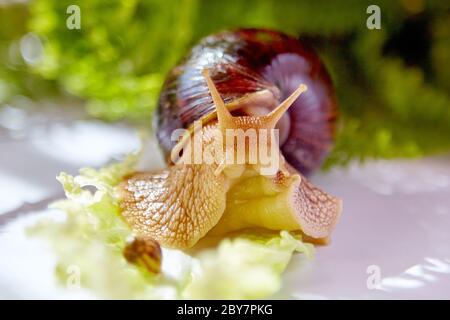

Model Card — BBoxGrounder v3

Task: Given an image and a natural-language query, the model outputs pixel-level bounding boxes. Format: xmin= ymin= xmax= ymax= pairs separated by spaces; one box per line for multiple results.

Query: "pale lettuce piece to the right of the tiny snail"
xmin=183 ymin=231 xmax=314 ymax=299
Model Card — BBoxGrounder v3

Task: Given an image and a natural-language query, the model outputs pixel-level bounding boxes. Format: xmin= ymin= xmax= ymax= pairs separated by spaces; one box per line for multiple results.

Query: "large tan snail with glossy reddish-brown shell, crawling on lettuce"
xmin=118 ymin=29 xmax=342 ymax=249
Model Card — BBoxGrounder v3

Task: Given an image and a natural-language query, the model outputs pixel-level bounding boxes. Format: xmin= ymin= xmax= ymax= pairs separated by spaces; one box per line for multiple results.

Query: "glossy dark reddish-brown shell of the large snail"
xmin=156 ymin=29 xmax=337 ymax=174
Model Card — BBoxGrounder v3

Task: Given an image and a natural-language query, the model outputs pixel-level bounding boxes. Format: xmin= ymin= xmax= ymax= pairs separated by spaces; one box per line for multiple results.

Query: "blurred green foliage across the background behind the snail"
xmin=0 ymin=0 xmax=450 ymax=168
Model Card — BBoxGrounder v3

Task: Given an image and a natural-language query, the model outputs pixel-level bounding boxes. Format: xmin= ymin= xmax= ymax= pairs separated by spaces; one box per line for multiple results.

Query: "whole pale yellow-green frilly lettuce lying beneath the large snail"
xmin=29 ymin=155 xmax=314 ymax=299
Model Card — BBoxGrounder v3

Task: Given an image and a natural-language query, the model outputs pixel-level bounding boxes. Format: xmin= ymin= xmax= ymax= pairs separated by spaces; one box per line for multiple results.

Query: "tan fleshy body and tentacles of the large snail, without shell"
xmin=119 ymin=29 xmax=342 ymax=249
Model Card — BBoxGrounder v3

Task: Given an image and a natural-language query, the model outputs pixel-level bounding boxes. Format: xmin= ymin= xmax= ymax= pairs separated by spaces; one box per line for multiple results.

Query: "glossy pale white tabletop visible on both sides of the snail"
xmin=0 ymin=106 xmax=450 ymax=299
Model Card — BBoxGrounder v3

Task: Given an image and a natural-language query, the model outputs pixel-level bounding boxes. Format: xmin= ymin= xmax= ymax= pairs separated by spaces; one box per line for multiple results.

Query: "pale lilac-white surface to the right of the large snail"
xmin=278 ymin=157 xmax=450 ymax=299
